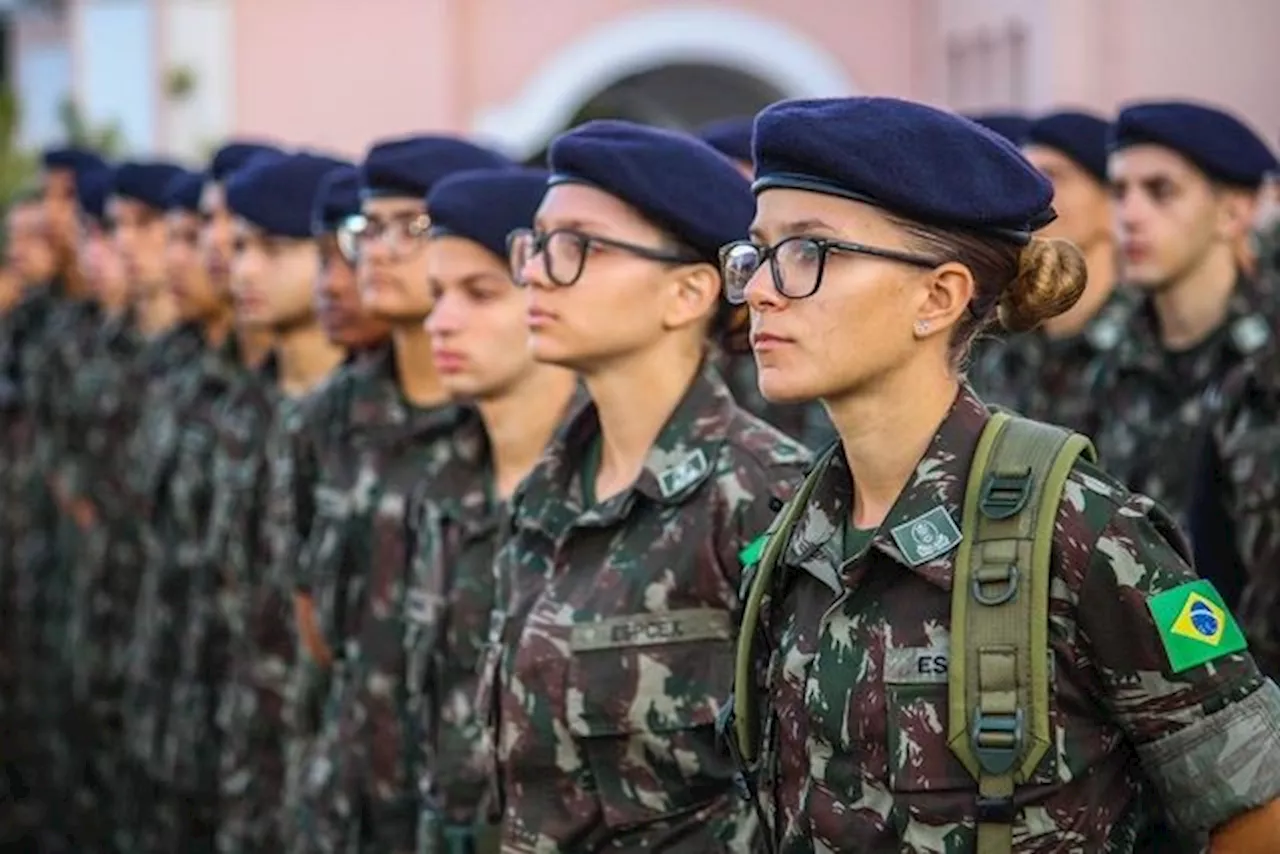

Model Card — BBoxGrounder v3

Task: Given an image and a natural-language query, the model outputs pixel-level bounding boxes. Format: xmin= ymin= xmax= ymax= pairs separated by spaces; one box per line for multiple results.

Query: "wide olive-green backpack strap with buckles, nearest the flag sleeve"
xmin=947 ymin=412 xmax=1096 ymax=854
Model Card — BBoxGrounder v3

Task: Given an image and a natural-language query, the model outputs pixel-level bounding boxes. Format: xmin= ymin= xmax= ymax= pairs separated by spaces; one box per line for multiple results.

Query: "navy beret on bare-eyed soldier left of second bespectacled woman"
xmin=426 ymin=166 xmax=550 ymax=259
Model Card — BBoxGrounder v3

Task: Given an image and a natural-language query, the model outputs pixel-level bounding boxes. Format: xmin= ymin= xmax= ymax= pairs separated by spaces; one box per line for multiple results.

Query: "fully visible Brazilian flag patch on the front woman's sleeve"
xmin=1147 ymin=579 xmax=1248 ymax=673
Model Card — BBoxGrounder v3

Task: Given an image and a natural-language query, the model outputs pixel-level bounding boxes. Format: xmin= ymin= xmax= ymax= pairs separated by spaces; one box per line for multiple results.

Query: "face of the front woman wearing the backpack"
xmin=745 ymin=189 xmax=946 ymax=402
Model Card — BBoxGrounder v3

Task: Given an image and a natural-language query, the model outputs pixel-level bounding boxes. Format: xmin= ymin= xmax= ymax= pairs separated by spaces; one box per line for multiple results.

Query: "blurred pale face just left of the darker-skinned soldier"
xmin=232 ymin=218 xmax=320 ymax=333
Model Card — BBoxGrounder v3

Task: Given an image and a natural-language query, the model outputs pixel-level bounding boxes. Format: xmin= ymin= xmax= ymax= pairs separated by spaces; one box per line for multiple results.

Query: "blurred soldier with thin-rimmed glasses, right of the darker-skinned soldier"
xmin=291 ymin=137 xmax=509 ymax=851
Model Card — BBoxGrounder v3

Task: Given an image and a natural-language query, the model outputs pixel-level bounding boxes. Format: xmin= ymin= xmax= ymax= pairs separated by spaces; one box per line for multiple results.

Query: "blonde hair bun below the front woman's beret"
xmin=998 ymin=237 xmax=1088 ymax=332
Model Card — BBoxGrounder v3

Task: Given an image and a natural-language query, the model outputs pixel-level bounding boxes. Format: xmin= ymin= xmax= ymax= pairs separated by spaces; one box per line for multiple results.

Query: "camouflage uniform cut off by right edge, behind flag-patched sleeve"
xmin=1189 ymin=346 xmax=1280 ymax=679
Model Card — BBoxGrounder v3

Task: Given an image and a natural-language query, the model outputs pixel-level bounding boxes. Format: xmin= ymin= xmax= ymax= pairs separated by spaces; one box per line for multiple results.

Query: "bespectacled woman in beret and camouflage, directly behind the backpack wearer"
xmin=481 ymin=122 xmax=806 ymax=854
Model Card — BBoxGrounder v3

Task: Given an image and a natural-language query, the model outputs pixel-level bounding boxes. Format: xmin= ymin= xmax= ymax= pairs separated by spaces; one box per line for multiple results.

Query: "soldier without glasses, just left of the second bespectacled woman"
xmin=404 ymin=169 xmax=577 ymax=854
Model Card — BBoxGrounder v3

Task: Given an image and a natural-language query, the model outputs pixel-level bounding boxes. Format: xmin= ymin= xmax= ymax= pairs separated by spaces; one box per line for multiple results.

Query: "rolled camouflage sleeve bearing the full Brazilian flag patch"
xmin=1078 ymin=495 xmax=1280 ymax=832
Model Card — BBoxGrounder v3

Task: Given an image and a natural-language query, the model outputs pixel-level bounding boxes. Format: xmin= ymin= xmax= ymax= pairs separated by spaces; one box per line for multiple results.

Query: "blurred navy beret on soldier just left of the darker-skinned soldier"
xmin=227 ymin=151 xmax=346 ymax=238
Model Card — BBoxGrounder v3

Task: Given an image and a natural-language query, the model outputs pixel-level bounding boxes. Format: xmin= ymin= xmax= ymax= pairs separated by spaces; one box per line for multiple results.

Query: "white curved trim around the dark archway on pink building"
xmin=472 ymin=6 xmax=855 ymax=157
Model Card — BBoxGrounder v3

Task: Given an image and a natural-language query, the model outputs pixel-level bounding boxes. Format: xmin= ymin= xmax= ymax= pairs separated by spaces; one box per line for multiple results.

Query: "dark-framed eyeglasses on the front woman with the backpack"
xmin=719 ymin=237 xmax=941 ymax=305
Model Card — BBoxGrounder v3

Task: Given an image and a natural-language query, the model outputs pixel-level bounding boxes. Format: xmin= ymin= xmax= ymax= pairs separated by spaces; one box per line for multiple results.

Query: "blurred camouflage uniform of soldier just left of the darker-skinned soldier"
xmin=216 ymin=382 xmax=313 ymax=854
